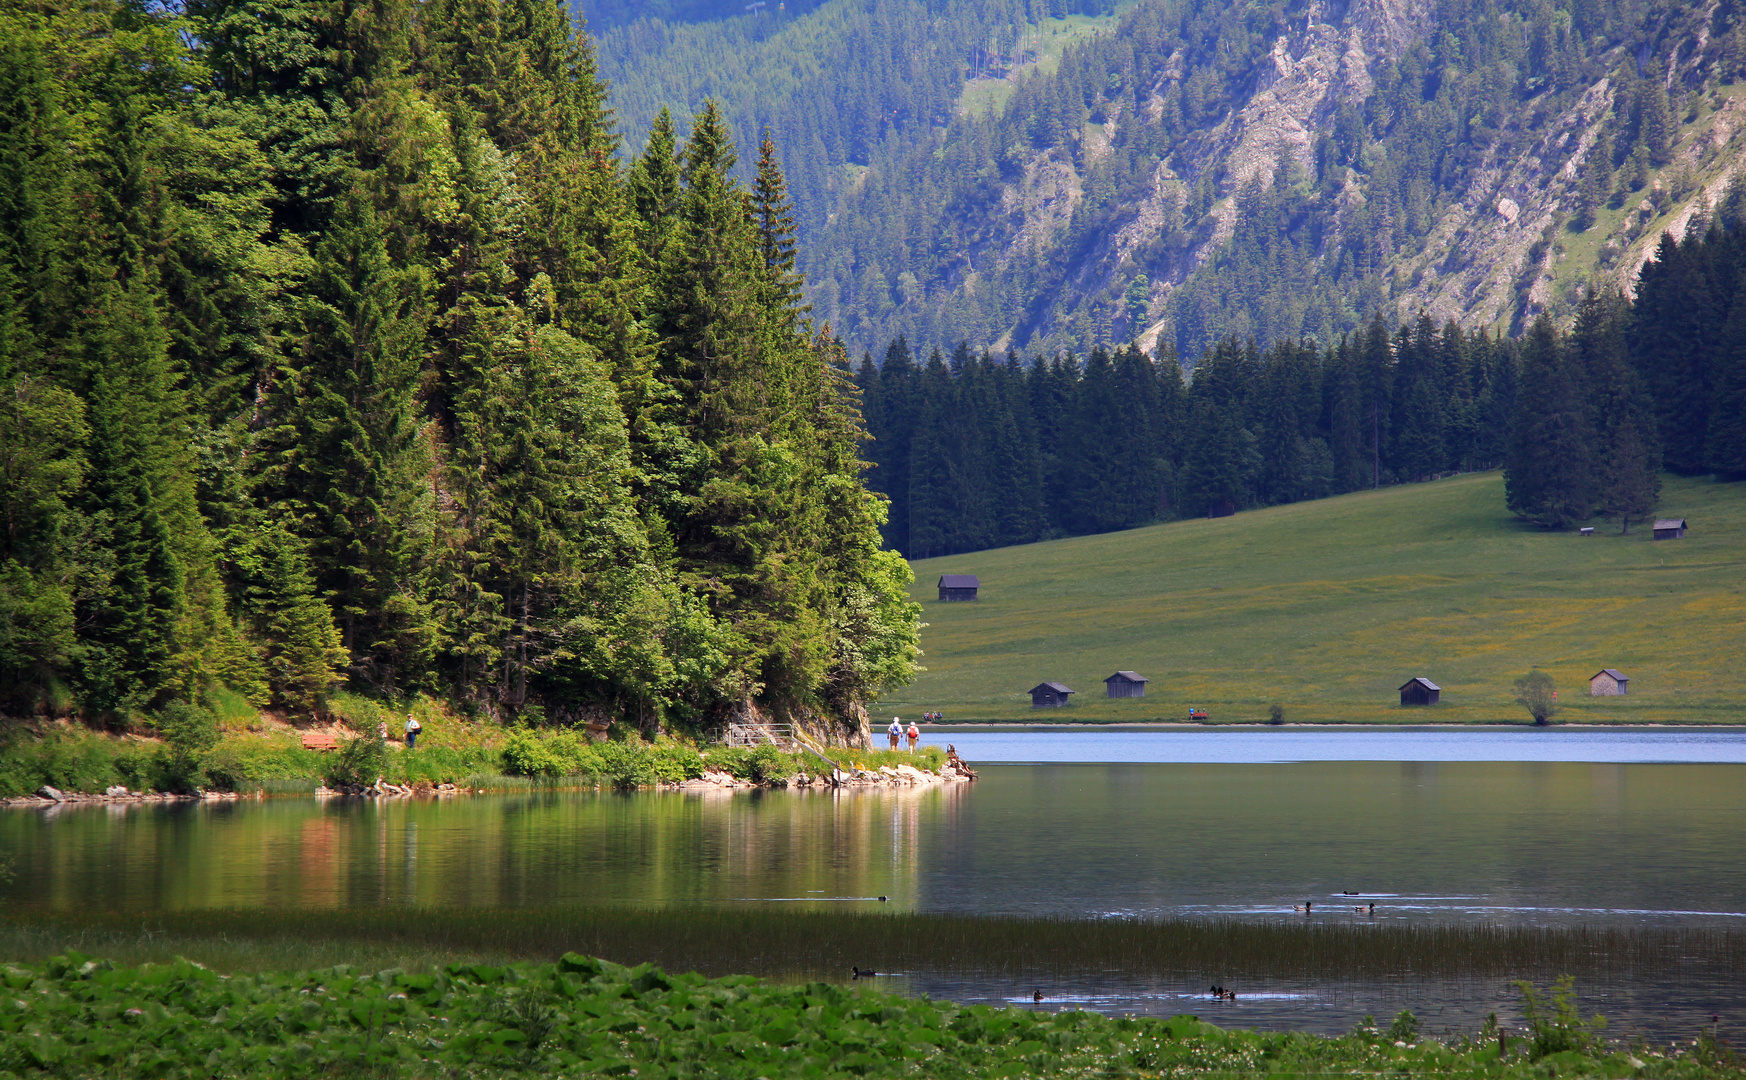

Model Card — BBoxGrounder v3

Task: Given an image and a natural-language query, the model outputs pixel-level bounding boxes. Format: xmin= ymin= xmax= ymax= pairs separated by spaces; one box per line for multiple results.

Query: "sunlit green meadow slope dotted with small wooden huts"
xmin=882 ymin=473 xmax=1746 ymax=722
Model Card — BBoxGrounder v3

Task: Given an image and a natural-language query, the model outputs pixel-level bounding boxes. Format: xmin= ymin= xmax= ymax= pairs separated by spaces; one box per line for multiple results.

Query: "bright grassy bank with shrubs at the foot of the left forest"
xmin=0 ymin=722 xmax=945 ymax=797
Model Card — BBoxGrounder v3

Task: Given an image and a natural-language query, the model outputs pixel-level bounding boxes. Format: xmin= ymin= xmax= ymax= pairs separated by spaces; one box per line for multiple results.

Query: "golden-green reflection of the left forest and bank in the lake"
xmin=0 ymin=787 xmax=966 ymax=911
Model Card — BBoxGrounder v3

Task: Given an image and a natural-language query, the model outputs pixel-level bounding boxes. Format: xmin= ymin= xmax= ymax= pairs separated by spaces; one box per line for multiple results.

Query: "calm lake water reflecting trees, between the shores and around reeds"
xmin=0 ymin=729 xmax=1746 ymax=1029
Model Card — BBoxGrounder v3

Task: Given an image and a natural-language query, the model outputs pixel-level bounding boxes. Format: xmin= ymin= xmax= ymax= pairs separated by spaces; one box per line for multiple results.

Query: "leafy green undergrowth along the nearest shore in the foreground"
xmin=0 ymin=953 xmax=1743 ymax=1080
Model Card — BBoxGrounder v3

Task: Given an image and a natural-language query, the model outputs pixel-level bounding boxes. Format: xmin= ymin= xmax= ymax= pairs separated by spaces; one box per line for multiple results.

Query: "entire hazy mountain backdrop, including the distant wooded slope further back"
xmin=604 ymin=0 xmax=1746 ymax=356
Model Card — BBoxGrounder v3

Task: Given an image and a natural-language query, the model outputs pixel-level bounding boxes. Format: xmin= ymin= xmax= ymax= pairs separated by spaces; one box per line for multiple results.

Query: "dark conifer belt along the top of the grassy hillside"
xmin=856 ymin=199 xmax=1746 ymax=558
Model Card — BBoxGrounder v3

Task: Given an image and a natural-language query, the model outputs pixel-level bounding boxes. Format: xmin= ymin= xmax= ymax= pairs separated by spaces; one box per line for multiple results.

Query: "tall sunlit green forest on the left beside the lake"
xmin=0 ymin=0 xmax=918 ymax=728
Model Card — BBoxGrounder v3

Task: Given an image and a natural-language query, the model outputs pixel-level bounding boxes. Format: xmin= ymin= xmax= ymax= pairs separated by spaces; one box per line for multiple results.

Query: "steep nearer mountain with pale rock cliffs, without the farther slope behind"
xmin=726 ymin=0 xmax=1746 ymax=356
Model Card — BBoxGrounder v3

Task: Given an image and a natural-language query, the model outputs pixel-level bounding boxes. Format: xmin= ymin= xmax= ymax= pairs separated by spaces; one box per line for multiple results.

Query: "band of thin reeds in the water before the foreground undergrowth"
xmin=0 ymin=907 xmax=1746 ymax=981
